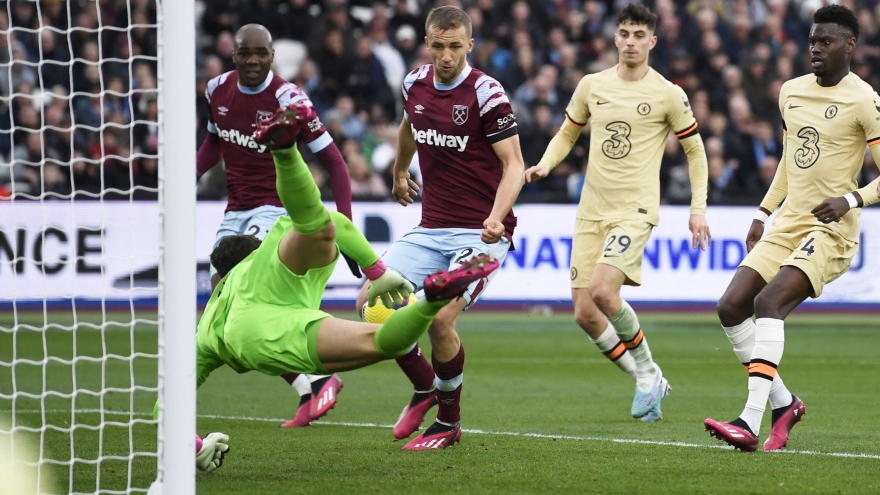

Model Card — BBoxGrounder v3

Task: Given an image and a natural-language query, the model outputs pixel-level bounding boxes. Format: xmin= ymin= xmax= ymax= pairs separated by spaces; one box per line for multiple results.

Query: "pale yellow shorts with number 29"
xmin=571 ymin=218 xmax=654 ymax=289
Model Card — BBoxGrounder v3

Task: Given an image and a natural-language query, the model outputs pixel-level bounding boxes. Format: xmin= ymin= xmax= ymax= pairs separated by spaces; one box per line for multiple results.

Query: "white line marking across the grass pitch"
xmin=8 ymin=409 xmax=880 ymax=460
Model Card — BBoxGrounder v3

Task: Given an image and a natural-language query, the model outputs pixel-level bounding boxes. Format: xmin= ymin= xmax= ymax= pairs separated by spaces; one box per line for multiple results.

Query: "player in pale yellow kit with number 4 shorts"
xmin=704 ymin=5 xmax=880 ymax=452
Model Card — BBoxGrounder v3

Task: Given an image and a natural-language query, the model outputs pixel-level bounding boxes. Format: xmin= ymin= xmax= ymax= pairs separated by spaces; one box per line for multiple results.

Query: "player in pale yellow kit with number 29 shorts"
xmin=525 ymin=4 xmax=711 ymax=422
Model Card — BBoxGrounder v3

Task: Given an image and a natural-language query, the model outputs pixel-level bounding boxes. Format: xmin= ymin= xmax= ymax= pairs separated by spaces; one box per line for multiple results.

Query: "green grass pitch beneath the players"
xmin=0 ymin=313 xmax=880 ymax=495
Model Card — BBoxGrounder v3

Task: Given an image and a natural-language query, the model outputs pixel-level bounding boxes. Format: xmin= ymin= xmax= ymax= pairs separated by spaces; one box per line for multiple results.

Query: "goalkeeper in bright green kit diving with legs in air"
xmin=178 ymin=105 xmax=498 ymax=469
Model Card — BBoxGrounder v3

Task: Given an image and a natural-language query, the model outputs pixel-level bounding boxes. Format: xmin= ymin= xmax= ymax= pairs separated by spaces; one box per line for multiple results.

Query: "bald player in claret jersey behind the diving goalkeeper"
xmin=196 ymin=24 xmax=352 ymax=426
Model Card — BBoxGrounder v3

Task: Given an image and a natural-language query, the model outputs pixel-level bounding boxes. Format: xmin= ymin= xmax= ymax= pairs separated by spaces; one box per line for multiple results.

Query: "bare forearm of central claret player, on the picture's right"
xmin=480 ymin=134 xmax=525 ymax=244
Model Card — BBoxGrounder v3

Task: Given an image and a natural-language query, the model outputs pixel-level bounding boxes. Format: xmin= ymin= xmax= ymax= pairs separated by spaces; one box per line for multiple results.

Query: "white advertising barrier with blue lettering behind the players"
xmin=0 ymin=202 xmax=880 ymax=311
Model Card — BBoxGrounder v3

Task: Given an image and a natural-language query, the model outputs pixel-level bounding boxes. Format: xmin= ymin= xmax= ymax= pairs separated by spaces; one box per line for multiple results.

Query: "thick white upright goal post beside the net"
xmin=157 ymin=0 xmax=196 ymax=495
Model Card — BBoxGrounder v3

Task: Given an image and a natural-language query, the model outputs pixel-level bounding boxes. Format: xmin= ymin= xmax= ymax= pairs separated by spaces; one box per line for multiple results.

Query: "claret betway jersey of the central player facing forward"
xmin=402 ymin=64 xmax=517 ymax=238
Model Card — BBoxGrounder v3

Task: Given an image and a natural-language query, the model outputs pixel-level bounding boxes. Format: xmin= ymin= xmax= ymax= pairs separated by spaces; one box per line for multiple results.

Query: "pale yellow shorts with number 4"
xmin=740 ymin=231 xmax=859 ymax=297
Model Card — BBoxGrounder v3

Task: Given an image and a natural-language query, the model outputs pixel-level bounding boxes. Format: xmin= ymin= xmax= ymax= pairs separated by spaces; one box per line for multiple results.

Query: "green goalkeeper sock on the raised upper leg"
xmin=272 ymin=146 xmax=330 ymax=235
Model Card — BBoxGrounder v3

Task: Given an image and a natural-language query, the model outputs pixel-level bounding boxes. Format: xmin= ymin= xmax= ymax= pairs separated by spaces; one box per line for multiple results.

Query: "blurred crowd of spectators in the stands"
xmin=0 ymin=0 xmax=880 ymax=205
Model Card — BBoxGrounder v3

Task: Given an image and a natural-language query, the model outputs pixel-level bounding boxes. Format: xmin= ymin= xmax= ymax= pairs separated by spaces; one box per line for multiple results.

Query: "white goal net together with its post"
xmin=0 ymin=0 xmax=196 ymax=494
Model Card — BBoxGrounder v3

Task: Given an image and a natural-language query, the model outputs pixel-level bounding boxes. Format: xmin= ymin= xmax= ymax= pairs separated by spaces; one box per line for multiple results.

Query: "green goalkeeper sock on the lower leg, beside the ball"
xmin=373 ymin=298 xmax=449 ymax=358
